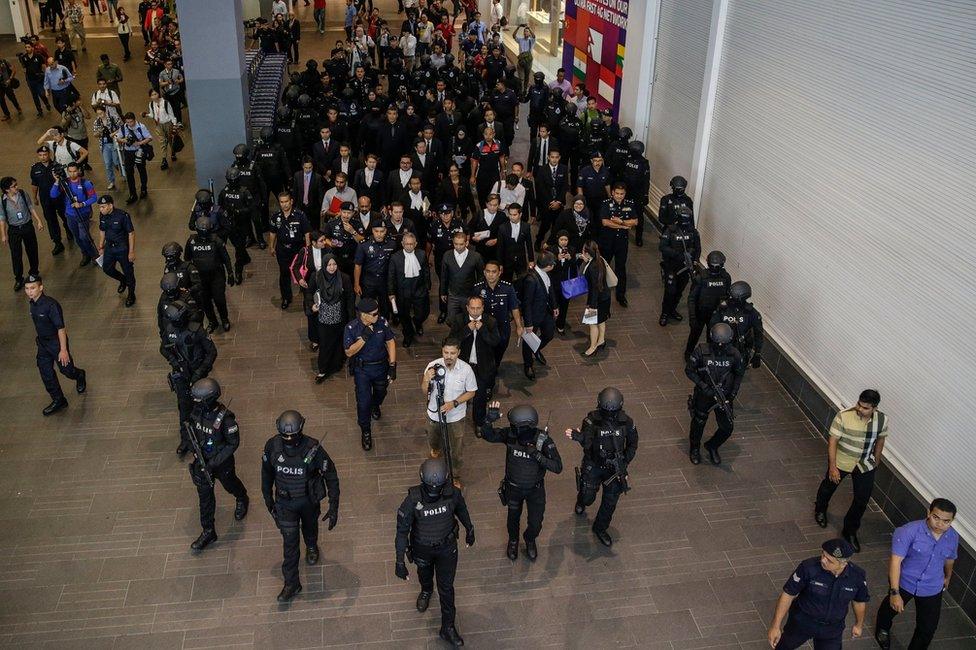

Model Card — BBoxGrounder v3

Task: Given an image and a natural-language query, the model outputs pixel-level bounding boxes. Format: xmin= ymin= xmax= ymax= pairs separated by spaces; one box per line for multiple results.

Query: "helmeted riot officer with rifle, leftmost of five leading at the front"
xmin=186 ymin=378 xmax=250 ymax=551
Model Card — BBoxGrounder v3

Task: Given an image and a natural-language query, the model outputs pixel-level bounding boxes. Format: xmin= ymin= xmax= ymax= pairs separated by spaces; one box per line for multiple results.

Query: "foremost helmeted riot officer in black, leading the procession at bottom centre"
xmin=396 ymin=458 xmax=474 ymax=648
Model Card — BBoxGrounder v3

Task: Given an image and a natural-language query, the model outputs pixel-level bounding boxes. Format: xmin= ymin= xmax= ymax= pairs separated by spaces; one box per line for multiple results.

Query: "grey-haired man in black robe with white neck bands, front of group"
xmin=386 ymin=230 xmax=430 ymax=348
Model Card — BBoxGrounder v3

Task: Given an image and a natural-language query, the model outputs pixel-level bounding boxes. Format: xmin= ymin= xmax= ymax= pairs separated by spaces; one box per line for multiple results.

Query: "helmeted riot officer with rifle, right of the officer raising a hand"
xmin=566 ymin=386 xmax=637 ymax=546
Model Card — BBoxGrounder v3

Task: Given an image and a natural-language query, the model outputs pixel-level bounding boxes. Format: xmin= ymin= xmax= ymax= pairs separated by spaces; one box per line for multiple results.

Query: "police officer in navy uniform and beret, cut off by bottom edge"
xmin=767 ymin=539 xmax=870 ymax=650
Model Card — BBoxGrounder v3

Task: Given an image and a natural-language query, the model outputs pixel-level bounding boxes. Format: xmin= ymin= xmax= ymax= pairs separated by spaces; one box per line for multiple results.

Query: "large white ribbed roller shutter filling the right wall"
xmin=696 ymin=0 xmax=976 ymax=542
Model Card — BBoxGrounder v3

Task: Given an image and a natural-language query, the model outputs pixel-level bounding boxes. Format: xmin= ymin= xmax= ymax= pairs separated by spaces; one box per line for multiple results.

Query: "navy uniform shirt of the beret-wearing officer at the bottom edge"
xmin=783 ymin=557 xmax=870 ymax=623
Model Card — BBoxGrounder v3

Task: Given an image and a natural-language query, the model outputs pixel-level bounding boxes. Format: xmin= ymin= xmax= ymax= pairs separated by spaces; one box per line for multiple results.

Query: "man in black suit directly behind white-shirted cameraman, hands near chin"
xmin=447 ymin=296 xmax=501 ymax=431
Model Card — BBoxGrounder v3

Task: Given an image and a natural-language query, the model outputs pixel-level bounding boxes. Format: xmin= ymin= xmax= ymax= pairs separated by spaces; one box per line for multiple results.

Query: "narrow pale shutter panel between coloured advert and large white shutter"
xmin=647 ymin=0 xmax=713 ymax=204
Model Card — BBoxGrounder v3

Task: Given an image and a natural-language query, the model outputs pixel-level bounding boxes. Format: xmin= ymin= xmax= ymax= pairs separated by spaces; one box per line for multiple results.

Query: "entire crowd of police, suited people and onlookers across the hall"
xmin=7 ymin=0 xmax=958 ymax=650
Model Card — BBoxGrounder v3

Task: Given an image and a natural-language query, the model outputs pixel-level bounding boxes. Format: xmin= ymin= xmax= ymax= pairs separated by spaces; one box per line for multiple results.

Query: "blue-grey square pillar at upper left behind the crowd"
xmin=176 ymin=0 xmax=248 ymax=187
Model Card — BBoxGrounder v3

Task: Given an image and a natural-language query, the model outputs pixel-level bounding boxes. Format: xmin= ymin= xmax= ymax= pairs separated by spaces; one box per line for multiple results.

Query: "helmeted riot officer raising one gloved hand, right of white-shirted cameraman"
xmin=481 ymin=402 xmax=563 ymax=562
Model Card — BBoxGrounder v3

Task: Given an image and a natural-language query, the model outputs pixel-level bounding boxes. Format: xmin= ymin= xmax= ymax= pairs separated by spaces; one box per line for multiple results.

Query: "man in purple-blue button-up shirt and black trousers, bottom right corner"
xmin=874 ymin=499 xmax=959 ymax=650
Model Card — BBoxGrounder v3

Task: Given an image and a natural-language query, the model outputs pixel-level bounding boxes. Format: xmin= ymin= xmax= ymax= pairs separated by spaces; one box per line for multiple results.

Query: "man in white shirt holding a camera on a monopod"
xmin=420 ymin=337 xmax=478 ymax=488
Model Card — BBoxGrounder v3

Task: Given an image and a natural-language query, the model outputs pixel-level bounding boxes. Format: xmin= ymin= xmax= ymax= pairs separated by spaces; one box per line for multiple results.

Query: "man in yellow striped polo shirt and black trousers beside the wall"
xmin=813 ymin=388 xmax=888 ymax=552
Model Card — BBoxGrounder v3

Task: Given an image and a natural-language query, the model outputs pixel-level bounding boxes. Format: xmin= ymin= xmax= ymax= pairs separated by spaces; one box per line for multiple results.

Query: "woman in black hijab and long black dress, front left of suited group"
xmin=312 ymin=254 xmax=356 ymax=384
